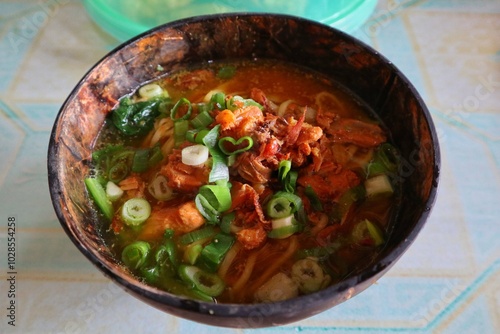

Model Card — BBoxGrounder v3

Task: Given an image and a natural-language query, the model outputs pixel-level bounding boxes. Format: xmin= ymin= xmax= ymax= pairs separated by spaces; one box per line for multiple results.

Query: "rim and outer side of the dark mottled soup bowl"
xmin=47 ymin=12 xmax=441 ymax=327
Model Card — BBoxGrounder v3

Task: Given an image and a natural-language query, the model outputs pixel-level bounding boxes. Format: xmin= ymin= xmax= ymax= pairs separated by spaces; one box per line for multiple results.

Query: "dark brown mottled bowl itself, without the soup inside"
xmin=48 ymin=14 xmax=440 ymax=327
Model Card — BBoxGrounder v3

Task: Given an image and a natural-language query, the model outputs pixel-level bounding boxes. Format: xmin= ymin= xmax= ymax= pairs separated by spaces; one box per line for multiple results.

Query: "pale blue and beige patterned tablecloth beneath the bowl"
xmin=0 ymin=0 xmax=500 ymax=334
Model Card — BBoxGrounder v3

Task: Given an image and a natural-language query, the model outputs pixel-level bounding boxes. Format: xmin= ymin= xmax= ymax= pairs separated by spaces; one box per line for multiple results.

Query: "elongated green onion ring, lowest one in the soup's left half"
xmin=179 ymin=265 xmax=225 ymax=297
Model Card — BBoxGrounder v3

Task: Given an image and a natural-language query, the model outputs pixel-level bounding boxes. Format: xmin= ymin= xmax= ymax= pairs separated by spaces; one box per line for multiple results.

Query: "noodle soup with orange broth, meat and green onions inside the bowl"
xmin=85 ymin=60 xmax=399 ymax=303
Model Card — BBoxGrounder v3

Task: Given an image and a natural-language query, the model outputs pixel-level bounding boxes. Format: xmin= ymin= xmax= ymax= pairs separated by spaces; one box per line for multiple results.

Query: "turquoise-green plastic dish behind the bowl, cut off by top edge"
xmin=83 ymin=0 xmax=377 ymax=42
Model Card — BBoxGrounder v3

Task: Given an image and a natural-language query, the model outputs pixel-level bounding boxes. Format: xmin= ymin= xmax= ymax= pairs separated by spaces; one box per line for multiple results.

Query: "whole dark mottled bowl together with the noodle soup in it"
xmin=48 ymin=14 xmax=440 ymax=328
